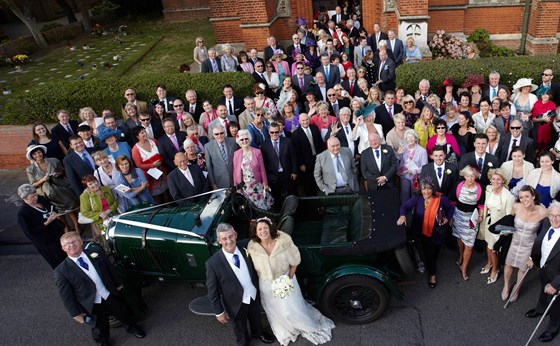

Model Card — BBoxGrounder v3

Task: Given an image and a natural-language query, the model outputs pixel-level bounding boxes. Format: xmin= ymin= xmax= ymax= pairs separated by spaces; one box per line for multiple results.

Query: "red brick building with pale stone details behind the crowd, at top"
xmin=162 ymin=0 xmax=560 ymax=54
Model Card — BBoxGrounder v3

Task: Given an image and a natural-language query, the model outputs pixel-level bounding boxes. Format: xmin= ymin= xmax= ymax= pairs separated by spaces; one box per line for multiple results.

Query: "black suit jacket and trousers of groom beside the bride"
xmin=206 ymin=246 xmax=262 ymax=345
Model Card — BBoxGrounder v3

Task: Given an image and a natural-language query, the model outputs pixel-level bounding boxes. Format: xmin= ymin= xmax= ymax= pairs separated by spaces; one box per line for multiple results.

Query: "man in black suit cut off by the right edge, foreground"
xmin=525 ymin=201 xmax=560 ymax=342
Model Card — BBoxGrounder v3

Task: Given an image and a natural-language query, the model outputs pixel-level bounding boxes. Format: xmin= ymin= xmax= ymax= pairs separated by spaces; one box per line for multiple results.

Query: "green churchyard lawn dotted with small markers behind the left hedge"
xmin=0 ymin=19 xmax=215 ymax=119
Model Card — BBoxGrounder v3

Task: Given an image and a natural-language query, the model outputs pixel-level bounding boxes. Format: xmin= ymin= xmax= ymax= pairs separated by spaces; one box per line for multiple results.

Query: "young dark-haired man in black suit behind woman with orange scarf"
xmin=420 ymin=145 xmax=459 ymax=198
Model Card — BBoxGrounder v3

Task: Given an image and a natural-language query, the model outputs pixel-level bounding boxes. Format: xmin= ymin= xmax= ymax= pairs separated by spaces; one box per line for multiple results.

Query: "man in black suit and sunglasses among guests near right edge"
xmin=496 ymin=119 xmax=535 ymax=166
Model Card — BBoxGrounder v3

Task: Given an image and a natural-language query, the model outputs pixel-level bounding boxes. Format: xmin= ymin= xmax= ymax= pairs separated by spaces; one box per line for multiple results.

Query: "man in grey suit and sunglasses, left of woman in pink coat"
xmin=204 ymin=125 xmax=239 ymax=190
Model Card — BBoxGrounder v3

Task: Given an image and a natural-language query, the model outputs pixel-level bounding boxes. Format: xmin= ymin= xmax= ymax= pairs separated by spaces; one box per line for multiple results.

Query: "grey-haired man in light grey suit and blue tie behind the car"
xmin=314 ymin=137 xmax=359 ymax=195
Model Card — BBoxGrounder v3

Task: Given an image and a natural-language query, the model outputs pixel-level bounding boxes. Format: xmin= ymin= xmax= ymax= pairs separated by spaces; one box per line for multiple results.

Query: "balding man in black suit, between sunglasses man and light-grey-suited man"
xmin=291 ymin=113 xmax=325 ymax=196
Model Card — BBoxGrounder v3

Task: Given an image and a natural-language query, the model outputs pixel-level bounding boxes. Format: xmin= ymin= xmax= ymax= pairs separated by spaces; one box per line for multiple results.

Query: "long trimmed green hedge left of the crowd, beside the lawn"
xmin=4 ymin=72 xmax=254 ymax=125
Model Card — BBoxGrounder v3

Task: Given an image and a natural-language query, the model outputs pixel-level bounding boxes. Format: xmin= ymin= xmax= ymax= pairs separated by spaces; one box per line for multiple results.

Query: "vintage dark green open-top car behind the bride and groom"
xmin=107 ymin=189 xmax=413 ymax=324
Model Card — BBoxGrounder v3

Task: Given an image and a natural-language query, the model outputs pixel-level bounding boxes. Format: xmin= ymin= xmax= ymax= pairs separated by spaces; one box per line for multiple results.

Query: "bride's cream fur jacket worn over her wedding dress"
xmin=247 ymin=231 xmax=301 ymax=281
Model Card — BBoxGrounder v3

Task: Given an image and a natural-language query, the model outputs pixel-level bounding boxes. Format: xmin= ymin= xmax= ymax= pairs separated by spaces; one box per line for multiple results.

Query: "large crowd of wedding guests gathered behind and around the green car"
xmin=13 ymin=8 xmax=560 ymax=339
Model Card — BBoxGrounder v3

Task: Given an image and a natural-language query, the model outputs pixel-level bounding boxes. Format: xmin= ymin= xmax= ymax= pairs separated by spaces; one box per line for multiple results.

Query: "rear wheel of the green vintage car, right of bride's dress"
xmin=320 ymin=275 xmax=390 ymax=324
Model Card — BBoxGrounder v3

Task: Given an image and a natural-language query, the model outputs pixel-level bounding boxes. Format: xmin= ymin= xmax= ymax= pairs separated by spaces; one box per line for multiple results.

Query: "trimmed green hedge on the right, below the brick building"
xmin=397 ymin=55 xmax=560 ymax=95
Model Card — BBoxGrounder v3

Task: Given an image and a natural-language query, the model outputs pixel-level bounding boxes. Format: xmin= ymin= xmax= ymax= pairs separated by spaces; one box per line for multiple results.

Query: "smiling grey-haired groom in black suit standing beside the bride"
xmin=206 ymin=223 xmax=274 ymax=346
